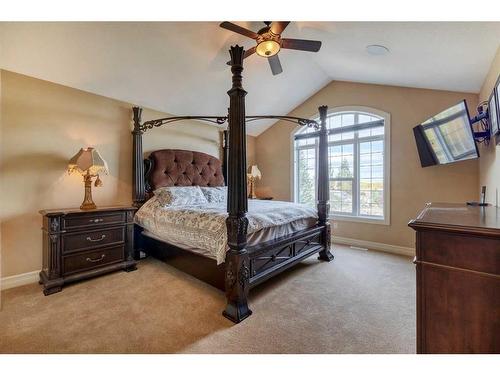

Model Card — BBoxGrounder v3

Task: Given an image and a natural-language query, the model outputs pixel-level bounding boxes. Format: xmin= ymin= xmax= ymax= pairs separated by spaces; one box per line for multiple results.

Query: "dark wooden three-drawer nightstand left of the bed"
xmin=40 ymin=206 xmax=137 ymax=295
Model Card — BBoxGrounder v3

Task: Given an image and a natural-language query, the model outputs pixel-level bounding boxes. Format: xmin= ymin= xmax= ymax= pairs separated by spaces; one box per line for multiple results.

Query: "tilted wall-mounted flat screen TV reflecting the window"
xmin=413 ymin=100 xmax=479 ymax=167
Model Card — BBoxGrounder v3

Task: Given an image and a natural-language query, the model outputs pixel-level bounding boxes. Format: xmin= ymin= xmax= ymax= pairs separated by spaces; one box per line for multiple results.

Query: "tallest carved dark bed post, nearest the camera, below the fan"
xmin=222 ymin=45 xmax=252 ymax=323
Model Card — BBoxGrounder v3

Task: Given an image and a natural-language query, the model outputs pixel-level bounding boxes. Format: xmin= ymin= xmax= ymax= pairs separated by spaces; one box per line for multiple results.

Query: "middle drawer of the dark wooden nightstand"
xmin=62 ymin=226 xmax=125 ymax=253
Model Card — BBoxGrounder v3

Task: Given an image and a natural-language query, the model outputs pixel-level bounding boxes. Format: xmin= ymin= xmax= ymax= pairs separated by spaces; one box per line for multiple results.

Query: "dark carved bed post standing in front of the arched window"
xmin=318 ymin=105 xmax=333 ymax=262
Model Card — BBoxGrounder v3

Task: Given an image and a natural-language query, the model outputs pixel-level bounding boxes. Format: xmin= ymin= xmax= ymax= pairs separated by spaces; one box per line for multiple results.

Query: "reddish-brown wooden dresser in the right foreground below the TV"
xmin=408 ymin=203 xmax=500 ymax=353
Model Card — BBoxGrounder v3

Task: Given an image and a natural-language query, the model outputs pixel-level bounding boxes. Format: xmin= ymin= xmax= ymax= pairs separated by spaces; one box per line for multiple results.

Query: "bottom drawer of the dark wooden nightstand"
xmin=63 ymin=245 xmax=124 ymax=275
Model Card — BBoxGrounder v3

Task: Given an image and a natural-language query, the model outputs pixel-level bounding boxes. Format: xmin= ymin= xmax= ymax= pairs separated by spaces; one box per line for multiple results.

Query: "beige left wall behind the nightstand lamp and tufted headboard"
xmin=0 ymin=71 xmax=255 ymax=277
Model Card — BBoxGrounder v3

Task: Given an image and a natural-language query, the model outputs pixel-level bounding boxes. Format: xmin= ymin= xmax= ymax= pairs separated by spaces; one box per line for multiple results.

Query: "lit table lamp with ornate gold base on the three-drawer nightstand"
xmin=68 ymin=147 xmax=109 ymax=210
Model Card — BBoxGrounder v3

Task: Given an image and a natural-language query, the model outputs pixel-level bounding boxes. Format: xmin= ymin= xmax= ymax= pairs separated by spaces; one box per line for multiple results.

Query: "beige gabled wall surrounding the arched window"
xmin=256 ymin=82 xmax=479 ymax=247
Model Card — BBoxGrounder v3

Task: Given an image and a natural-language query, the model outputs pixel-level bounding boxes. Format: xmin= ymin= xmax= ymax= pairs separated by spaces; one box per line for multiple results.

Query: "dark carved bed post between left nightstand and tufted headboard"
xmin=132 ymin=107 xmax=146 ymax=207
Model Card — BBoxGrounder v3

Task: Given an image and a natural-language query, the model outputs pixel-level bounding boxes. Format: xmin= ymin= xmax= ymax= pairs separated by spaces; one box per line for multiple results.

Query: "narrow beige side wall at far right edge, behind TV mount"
xmin=479 ymin=47 xmax=500 ymax=209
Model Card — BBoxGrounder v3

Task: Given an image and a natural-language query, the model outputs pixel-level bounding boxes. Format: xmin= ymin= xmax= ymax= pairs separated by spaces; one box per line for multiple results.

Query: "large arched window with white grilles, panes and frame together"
xmin=293 ymin=107 xmax=390 ymax=224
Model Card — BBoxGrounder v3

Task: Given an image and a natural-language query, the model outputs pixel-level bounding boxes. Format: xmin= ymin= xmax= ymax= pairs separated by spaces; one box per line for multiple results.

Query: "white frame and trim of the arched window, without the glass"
xmin=291 ymin=106 xmax=391 ymax=225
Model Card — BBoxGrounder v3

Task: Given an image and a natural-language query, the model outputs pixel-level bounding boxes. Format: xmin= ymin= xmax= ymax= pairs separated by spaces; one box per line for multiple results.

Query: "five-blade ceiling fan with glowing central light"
xmin=220 ymin=21 xmax=321 ymax=75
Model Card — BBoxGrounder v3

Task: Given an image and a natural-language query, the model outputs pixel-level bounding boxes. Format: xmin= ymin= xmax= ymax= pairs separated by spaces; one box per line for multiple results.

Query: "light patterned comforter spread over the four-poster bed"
xmin=134 ymin=197 xmax=318 ymax=264
